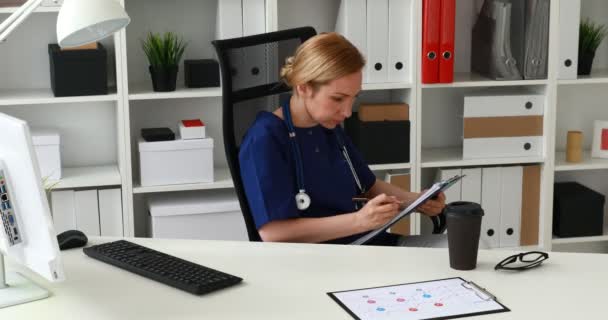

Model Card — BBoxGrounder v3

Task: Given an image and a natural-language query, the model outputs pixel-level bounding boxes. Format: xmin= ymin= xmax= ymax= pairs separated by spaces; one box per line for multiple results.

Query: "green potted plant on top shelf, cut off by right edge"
xmin=578 ymin=18 xmax=607 ymax=75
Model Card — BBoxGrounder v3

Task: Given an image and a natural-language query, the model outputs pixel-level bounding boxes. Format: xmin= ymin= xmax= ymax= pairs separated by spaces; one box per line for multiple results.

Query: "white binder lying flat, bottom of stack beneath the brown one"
xmin=462 ymin=136 xmax=543 ymax=159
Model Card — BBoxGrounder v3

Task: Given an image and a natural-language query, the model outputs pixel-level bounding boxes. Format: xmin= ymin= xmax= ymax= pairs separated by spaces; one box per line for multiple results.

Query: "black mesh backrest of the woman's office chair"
xmin=212 ymin=27 xmax=316 ymax=241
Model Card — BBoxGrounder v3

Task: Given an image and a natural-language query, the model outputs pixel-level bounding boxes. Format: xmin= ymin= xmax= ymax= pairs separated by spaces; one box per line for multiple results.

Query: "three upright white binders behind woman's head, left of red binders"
xmin=335 ymin=0 xmax=414 ymax=83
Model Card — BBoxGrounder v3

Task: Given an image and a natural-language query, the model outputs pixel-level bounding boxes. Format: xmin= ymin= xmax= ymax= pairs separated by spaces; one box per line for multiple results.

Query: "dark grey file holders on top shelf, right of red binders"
xmin=471 ymin=0 xmax=550 ymax=80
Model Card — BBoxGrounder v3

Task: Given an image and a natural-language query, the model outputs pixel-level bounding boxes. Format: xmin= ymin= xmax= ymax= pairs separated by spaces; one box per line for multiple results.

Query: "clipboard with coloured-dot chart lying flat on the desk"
xmin=327 ymin=277 xmax=511 ymax=320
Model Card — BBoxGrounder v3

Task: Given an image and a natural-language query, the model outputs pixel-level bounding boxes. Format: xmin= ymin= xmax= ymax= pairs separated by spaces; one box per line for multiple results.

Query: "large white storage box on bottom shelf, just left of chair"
xmin=148 ymin=190 xmax=248 ymax=241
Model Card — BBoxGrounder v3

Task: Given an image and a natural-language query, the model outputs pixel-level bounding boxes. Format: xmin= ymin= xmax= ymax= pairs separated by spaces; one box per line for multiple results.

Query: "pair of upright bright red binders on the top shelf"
xmin=422 ymin=0 xmax=456 ymax=83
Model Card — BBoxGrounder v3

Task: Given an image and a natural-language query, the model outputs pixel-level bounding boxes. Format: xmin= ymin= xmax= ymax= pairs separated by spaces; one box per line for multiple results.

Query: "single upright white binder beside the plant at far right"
xmin=558 ymin=0 xmax=581 ymax=79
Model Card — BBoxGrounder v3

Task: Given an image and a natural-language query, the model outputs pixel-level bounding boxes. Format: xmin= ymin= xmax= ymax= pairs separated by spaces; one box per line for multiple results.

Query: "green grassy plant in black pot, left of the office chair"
xmin=142 ymin=32 xmax=187 ymax=92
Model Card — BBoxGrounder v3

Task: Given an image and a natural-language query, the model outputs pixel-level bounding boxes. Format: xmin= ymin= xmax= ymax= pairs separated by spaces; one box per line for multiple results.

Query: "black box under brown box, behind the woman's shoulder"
xmin=344 ymin=112 xmax=410 ymax=164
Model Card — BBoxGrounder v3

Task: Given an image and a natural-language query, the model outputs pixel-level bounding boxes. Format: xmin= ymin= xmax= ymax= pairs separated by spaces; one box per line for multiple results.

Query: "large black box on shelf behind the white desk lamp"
xmin=49 ymin=44 xmax=108 ymax=97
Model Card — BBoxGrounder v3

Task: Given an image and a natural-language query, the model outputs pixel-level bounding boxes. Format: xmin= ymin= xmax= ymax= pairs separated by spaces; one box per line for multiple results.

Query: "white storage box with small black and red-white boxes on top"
xmin=139 ymin=138 xmax=213 ymax=186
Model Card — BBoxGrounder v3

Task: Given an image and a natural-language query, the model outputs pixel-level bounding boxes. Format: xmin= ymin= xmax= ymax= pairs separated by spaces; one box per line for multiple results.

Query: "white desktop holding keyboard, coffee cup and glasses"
xmin=0 ymin=239 xmax=608 ymax=320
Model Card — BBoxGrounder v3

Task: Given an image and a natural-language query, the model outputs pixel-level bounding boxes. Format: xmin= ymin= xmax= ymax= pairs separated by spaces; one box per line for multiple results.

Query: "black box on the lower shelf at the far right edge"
xmin=553 ymin=182 xmax=605 ymax=237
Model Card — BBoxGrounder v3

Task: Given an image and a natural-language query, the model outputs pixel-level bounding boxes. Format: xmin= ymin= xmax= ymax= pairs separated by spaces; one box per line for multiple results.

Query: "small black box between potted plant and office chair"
xmin=184 ymin=59 xmax=220 ymax=88
